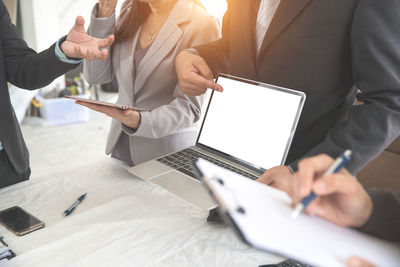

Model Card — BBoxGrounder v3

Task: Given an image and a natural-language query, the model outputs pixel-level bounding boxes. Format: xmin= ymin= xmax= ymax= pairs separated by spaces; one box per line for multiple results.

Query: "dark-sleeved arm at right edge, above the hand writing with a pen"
xmin=291 ymin=0 xmax=400 ymax=174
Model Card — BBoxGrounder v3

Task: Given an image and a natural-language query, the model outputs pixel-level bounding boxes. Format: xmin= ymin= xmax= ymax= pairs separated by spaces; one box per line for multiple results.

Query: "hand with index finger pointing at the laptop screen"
xmin=175 ymin=51 xmax=223 ymax=96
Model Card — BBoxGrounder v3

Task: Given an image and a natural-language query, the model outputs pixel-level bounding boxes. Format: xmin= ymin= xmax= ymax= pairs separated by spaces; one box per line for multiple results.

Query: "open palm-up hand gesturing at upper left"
xmin=61 ymin=16 xmax=114 ymax=60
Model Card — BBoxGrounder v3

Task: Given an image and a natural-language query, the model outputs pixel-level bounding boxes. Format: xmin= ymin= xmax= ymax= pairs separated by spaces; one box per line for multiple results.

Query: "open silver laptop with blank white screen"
xmin=128 ymin=74 xmax=306 ymax=210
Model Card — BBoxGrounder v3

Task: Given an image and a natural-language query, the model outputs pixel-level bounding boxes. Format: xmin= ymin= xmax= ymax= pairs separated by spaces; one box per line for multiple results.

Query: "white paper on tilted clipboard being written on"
xmin=196 ymin=159 xmax=400 ymax=267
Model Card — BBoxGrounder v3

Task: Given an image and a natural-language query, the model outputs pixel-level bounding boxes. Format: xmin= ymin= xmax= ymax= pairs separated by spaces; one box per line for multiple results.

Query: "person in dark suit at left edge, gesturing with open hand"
xmin=0 ymin=1 xmax=114 ymax=188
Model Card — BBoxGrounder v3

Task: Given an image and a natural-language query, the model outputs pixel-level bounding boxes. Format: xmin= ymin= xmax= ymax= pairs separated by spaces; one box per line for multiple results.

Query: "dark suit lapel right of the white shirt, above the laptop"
xmin=260 ymin=0 xmax=311 ymax=54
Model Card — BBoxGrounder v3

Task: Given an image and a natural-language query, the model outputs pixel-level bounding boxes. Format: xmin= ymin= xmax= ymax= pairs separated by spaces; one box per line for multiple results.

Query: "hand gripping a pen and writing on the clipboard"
xmin=290 ymin=155 xmax=372 ymax=227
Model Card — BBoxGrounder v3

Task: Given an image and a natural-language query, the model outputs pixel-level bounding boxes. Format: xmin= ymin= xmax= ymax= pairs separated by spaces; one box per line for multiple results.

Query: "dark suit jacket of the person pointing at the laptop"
xmin=196 ymin=0 xmax=400 ymax=173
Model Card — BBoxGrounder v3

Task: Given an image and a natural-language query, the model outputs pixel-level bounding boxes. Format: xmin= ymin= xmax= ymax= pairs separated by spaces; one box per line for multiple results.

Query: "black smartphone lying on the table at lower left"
xmin=0 ymin=206 xmax=44 ymax=236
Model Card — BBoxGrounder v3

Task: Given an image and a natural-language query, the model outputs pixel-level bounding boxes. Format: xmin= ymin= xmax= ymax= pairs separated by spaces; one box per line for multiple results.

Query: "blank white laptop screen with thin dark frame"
xmin=197 ymin=75 xmax=305 ymax=170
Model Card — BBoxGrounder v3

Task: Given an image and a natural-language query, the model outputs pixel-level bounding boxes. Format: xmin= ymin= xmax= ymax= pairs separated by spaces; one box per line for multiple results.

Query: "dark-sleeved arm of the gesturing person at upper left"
xmin=0 ymin=1 xmax=77 ymax=89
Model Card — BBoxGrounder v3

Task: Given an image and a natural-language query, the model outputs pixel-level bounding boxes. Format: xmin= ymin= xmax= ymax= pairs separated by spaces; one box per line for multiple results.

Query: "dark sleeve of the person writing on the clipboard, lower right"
xmin=359 ymin=189 xmax=400 ymax=242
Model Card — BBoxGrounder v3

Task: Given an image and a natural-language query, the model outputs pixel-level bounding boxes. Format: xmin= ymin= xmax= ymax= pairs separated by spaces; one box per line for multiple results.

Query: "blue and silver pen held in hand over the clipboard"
xmin=290 ymin=149 xmax=351 ymax=219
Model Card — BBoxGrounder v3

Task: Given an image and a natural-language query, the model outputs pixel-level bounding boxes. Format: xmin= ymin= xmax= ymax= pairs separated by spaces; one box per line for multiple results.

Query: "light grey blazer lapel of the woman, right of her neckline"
xmin=134 ymin=0 xmax=192 ymax=93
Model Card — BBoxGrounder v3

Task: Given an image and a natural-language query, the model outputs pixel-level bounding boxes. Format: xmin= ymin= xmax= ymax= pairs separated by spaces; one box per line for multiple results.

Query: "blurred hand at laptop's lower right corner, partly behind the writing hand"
xmin=257 ymin=166 xmax=293 ymax=194
